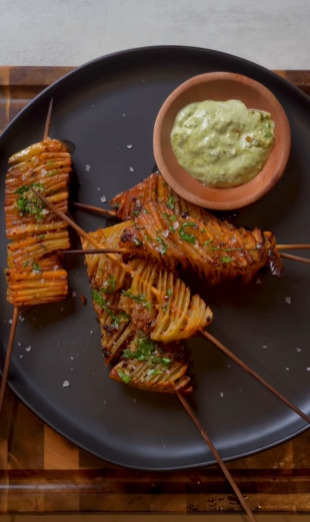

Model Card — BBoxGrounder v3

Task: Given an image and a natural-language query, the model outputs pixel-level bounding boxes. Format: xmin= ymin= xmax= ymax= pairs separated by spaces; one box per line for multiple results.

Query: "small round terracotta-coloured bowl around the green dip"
xmin=153 ymin=72 xmax=291 ymax=210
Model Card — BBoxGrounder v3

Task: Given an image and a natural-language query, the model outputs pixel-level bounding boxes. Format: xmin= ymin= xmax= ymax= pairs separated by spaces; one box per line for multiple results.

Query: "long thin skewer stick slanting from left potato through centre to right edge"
xmin=35 ymin=188 xmax=310 ymax=424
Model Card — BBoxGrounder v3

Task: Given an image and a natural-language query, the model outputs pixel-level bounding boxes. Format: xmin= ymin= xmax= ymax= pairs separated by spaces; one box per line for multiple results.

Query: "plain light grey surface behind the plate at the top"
xmin=0 ymin=0 xmax=310 ymax=69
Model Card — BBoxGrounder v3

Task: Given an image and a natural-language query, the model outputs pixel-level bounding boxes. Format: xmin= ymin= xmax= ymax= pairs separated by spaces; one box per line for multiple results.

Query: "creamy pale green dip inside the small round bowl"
xmin=171 ymin=100 xmax=275 ymax=188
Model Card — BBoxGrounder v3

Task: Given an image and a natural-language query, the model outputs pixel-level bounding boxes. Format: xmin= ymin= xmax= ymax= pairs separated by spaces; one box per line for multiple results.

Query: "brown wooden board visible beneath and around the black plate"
xmin=0 ymin=67 xmax=310 ymax=514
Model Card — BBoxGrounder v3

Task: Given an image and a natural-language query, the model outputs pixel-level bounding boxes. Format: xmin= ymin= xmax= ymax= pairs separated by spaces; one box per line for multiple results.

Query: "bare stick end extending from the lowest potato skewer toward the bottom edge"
xmin=177 ymin=392 xmax=256 ymax=522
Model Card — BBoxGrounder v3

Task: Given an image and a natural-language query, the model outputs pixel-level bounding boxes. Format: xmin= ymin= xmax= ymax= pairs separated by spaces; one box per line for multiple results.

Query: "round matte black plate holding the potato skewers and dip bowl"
xmin=0 ymin=47 xmax=310 ymax=469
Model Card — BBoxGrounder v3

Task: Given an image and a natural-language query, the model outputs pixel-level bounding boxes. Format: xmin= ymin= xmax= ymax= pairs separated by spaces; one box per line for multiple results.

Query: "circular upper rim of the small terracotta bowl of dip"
xmin=153 ymin=71 xmax=291 ymax=210
